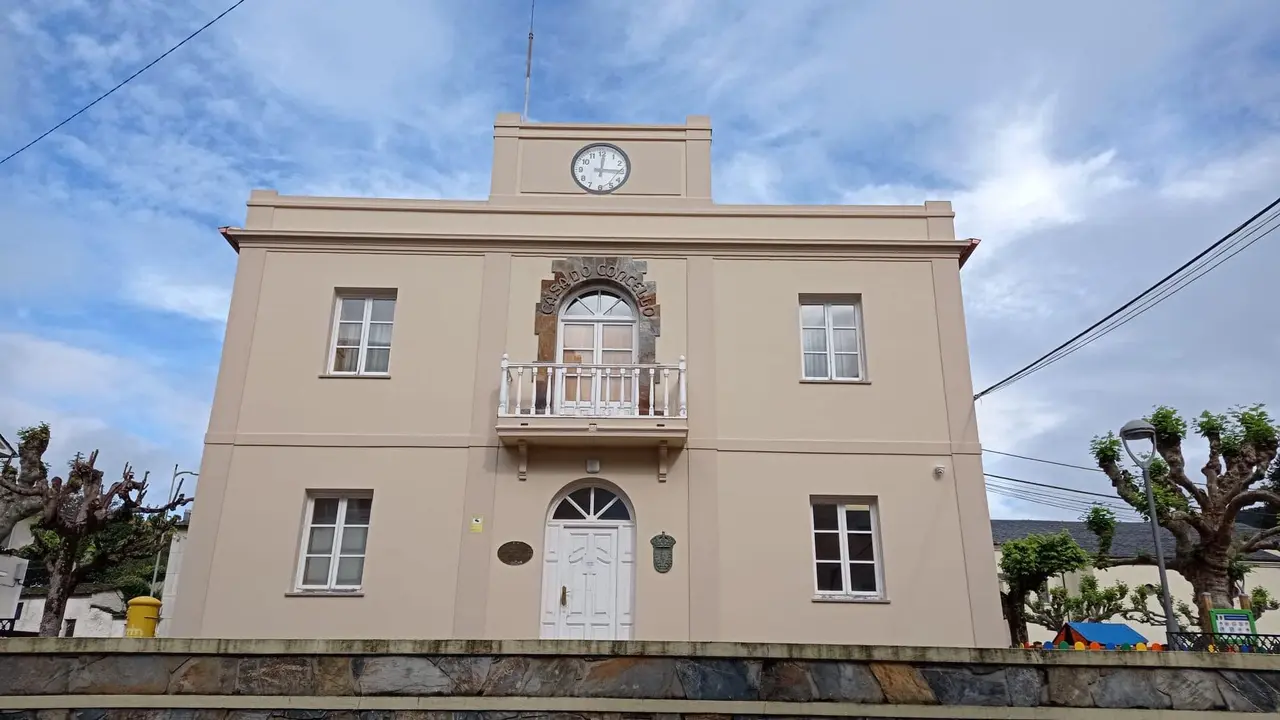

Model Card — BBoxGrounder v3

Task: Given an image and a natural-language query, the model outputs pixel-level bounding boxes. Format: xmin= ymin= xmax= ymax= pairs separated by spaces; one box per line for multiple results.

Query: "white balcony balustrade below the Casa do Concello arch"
xmin=498 ymin=355 xmax=689 ymax=418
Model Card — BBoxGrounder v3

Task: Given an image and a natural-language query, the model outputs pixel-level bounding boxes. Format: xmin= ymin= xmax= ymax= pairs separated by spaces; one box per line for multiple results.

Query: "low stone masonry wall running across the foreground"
xmin=0 ymin=638 xmax=1280 ymax=720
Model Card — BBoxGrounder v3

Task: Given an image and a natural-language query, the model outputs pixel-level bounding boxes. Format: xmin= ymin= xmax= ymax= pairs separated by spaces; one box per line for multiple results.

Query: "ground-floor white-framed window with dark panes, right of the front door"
xmin=813 ymin=501 xmax=883 ymax=597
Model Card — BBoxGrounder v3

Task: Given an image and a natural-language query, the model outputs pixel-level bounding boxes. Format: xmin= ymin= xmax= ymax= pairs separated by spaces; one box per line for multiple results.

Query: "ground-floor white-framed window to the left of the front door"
xmin=297 ymin=495 xmax=374 ymax=591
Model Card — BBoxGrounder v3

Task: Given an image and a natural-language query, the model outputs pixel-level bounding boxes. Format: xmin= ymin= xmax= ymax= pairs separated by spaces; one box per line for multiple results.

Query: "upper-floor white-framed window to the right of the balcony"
xmin=800 ymin=300 xmax=863 ymax=380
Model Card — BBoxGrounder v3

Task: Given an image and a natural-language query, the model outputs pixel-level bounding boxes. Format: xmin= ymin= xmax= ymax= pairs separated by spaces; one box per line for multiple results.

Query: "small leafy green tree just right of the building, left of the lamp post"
xmin=1000 ymin=530 xmax=1089 ymax=647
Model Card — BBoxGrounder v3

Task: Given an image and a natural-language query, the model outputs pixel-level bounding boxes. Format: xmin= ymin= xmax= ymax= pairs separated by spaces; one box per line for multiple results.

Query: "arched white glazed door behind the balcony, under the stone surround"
xmin=556 ymin=287 xmax=640 ymax=415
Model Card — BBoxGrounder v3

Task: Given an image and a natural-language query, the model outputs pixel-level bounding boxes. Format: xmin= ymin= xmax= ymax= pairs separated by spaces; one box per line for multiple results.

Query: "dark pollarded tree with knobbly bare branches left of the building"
xmin=0 ymin=451 xmax=191 ymax=637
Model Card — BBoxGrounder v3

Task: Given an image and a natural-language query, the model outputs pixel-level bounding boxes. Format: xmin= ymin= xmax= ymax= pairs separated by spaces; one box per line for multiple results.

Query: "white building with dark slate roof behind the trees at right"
xmin=991 ymin=520 xmax=1280 ymax=642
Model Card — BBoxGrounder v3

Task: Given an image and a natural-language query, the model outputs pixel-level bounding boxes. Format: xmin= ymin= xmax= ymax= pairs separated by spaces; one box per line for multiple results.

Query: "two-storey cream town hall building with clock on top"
xmin=172 ymin=114 xmax=1005 ymax=646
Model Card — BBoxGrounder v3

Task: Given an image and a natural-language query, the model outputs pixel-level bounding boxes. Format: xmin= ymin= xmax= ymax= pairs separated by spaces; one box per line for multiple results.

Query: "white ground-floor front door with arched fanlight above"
xmin=540 ymin=483 xmax=636 ymax=641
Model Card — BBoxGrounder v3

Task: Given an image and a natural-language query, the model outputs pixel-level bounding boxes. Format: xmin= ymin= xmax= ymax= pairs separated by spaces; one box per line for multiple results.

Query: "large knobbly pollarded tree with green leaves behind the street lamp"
xmin=1087 ymin=405 xmax=1280 ymax=628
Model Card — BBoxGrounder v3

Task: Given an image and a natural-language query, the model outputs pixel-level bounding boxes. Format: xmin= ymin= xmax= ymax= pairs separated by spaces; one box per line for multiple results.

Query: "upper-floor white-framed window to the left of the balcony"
xmin=329 ymin=295 xmax=396 ymax=375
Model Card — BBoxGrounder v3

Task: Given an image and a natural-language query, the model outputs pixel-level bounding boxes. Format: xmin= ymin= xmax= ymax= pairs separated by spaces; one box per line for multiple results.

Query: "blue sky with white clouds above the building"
xmin=0 ymin=0 xmax=1280 ymax=518
